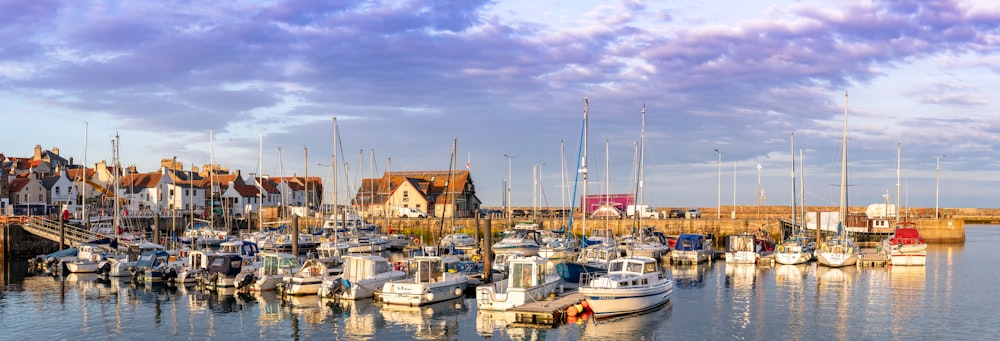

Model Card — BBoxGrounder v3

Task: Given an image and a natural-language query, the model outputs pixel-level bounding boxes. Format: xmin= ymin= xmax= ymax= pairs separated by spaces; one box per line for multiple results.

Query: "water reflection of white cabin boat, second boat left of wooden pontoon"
xmin=380 ymin=297 xmax=476 ymax=340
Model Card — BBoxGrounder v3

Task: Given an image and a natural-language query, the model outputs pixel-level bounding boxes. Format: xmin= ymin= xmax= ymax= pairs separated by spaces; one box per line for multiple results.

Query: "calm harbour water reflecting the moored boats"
xmin=0 ymin=225 xmax=1000 ymax=340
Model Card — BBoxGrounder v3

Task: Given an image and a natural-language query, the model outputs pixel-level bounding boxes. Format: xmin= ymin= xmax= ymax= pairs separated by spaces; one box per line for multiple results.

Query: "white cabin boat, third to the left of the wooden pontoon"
xmin=319 ymin=255 xmax=406 ymax=300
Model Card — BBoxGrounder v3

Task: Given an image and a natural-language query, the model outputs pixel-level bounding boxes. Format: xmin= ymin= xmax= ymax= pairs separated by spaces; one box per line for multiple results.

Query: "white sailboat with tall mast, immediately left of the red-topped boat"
xmin=816 ymin=93 xmax=860 ymax=268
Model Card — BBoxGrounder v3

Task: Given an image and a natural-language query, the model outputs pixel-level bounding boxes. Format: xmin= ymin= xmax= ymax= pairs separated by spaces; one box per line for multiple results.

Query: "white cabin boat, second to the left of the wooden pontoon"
xmin=382 ymin=256 xmax=469 ymax=306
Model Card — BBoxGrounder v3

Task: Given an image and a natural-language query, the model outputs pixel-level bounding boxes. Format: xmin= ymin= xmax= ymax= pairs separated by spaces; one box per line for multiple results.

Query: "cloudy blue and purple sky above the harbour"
xmin=0 ymin=0 xmax=1000 ymax=208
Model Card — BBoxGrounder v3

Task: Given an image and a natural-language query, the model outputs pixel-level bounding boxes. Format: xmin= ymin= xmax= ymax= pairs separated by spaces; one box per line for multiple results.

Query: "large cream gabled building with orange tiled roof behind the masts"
xmin=353 ymin=170 xmax=482 ymax=218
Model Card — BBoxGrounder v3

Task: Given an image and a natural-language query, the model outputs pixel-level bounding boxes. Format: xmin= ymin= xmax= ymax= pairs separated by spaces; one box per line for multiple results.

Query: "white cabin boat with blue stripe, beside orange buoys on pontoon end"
xmin=579 ymin=257 xmax=674 ymax=318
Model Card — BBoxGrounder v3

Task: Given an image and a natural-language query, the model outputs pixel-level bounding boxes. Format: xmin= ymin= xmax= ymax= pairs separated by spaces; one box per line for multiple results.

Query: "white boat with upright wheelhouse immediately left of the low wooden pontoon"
xmin=476 ymin=256 xmax=562 ymax=311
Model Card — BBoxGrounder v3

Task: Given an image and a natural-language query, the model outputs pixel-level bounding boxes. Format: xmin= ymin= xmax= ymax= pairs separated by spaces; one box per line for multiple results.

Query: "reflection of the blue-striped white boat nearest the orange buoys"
xmin=580 ymin=300 xmax=676 ymax=341
